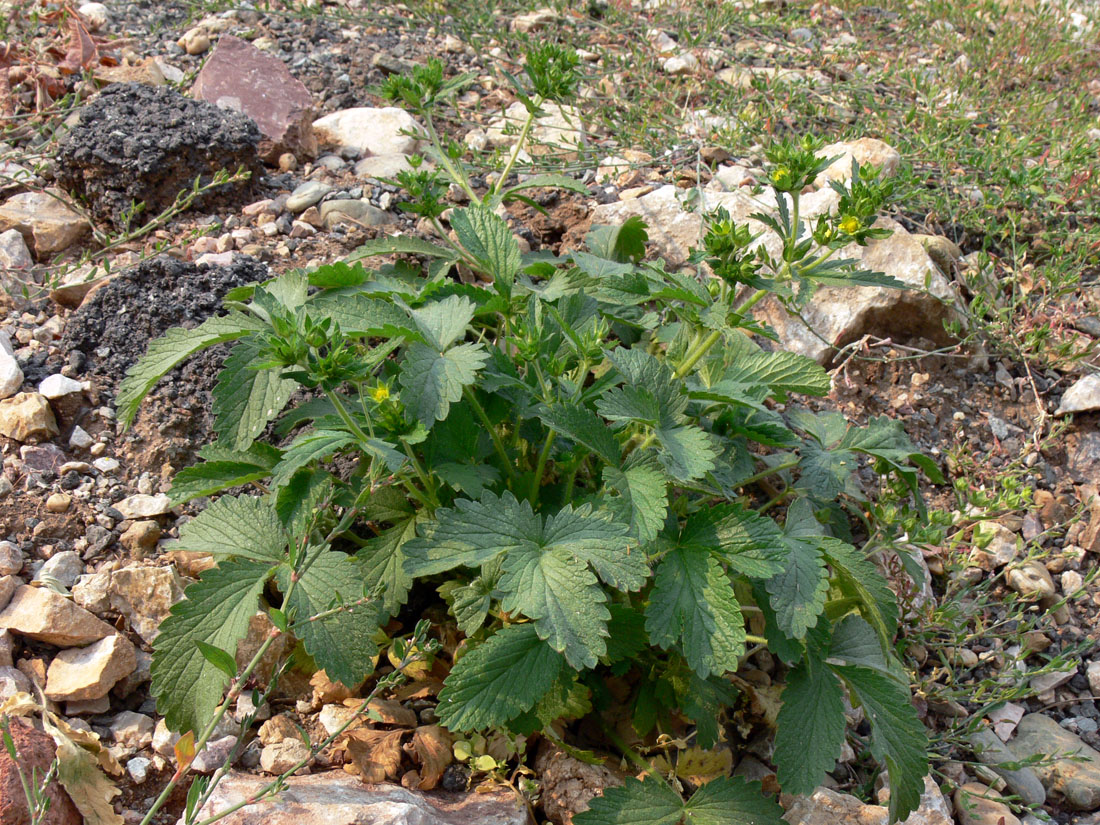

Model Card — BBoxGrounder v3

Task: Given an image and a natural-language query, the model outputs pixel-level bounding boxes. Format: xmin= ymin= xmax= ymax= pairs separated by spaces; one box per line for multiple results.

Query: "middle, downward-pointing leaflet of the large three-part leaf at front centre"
xmin=501 ymin=547 xmax=611 ymax=670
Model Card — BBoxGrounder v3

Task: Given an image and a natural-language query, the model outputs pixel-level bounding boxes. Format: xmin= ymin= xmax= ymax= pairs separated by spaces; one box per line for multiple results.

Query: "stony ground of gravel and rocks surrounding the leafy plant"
xmin=0 ymin=0 xmax=1100 ymax=825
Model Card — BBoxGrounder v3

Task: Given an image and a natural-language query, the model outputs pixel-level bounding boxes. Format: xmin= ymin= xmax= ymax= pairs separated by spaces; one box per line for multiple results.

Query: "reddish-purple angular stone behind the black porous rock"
xmin=191 ymin=34 xmax=317 ymax=163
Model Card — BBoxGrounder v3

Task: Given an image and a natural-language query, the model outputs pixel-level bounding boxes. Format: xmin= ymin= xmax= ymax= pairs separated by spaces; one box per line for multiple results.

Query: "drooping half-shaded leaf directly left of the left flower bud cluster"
xmin=212 ymin=340 xmax=298 ymax=450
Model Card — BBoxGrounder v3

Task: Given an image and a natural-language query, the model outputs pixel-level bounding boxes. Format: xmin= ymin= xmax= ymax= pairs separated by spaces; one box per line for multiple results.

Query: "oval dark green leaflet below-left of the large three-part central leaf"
xmin=436 ymin=625 xmax=564 ymax=732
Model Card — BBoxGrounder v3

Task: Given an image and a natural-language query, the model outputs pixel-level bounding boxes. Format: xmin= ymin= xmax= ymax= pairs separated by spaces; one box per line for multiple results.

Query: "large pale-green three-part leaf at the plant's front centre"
xmin=404 ymin=493 xmax=649 ymax=669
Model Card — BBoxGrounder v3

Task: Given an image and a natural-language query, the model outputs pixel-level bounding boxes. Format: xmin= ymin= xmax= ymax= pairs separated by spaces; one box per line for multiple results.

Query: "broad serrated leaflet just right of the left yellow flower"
xmin=400 ymin=343 xmax=488 ymax=427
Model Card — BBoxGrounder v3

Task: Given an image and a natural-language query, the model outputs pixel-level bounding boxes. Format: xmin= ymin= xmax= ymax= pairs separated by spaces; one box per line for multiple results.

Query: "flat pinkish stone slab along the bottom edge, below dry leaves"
xmin=180 ymin=771 xmax=528 ymax=825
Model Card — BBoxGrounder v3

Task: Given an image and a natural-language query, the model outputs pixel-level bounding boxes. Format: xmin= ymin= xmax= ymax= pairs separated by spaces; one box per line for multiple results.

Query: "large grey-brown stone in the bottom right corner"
xmin=1009 ymin=713 xmax=1100 ymax=811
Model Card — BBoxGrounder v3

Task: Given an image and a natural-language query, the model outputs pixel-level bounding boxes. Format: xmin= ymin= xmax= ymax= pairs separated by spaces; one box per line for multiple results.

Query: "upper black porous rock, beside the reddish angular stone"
xmin=57 ymin=84 xmax=263 ymax=226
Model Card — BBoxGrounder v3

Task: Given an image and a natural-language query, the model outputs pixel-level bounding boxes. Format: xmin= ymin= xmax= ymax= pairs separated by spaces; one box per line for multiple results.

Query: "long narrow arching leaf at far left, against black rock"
xmin=114 ymin=312 xmax=265 ymax=427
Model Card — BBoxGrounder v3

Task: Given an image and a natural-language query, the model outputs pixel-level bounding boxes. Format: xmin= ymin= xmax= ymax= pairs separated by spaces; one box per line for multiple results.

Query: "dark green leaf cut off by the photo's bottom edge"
xmin=573 ymin=777 xmax=783 ymax=825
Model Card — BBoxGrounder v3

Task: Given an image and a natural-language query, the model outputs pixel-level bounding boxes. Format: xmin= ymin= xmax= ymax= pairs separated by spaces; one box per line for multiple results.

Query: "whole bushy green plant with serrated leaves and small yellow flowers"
xmin=118 ymin=46 xmax=938 ymax=825
